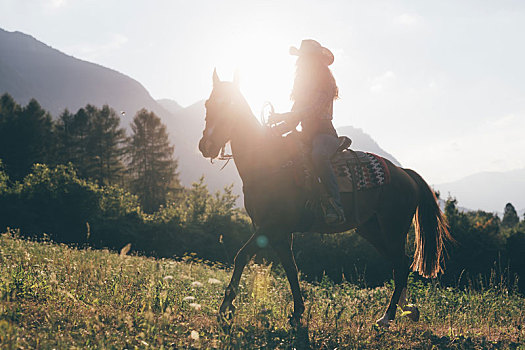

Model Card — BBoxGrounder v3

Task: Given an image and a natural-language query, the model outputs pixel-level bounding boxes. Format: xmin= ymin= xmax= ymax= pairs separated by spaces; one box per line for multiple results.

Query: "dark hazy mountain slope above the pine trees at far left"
xmin=0 ymin=29 xmax=169 ymax=125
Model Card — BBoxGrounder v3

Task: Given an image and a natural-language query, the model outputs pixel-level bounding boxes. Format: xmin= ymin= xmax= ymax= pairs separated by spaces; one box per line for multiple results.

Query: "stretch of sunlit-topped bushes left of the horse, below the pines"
xmin=0 ymin=164 xmax=250 ymax=263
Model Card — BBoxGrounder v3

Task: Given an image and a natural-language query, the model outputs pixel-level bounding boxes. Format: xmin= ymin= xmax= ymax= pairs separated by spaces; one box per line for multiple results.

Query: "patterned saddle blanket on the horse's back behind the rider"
xmin=331 ymin=150 xmax=390 ymax=192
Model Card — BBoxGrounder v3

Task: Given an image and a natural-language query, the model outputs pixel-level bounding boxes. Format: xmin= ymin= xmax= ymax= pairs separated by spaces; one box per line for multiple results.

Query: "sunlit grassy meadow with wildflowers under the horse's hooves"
xmin=0 ymin=234 xmax=525 ymax=349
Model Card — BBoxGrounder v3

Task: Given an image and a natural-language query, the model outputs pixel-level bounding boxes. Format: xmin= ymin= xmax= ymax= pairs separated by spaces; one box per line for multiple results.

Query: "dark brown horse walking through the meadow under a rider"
xmin=199 ymin=71 xmax=450 ymax=326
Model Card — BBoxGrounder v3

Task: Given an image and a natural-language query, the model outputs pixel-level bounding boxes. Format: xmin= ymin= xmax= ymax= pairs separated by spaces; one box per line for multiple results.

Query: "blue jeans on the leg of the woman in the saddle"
xmin=312 ymin=134 xmax=341 ymax=206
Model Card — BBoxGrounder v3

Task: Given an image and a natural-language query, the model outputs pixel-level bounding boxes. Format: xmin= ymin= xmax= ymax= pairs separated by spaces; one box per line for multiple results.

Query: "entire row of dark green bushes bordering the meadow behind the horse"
xmin=0 ymin=163 xmax=525 ymax=291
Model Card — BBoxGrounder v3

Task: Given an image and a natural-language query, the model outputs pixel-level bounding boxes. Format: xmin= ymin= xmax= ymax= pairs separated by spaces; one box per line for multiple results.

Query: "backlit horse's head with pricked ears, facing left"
xmin=199 ymin=70 xmax=240 ymax=159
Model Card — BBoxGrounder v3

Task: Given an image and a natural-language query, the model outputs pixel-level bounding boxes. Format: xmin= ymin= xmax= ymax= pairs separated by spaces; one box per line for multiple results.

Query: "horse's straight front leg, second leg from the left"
xmin=271 ymin=233 xmax=304 ymax=327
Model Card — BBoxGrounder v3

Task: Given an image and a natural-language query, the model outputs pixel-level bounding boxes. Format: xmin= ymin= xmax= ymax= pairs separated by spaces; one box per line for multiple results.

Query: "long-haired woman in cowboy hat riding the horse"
xmin=268 ymin=39 xmax=345 ymax=225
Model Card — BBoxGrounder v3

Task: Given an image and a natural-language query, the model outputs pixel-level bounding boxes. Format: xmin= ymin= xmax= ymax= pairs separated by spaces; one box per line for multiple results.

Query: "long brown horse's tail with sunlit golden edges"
xmin=404 ymin=169 xmax=453 ymax=278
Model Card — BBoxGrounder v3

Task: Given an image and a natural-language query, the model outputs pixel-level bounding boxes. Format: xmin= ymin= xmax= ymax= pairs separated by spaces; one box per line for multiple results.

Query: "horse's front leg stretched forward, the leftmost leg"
xmin=219 ymin=234 xmax=258 ymax=319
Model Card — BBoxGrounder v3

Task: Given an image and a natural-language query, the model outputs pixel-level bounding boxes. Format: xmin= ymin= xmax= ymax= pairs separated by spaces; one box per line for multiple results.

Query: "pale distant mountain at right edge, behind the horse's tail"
xmin=434 ymin=168 xmax=525 ymax=212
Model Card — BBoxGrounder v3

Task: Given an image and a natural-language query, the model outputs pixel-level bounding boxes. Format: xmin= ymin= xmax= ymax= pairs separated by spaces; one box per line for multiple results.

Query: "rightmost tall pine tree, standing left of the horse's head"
xmin=128 ymin=109 xmax=179 ymax=213
